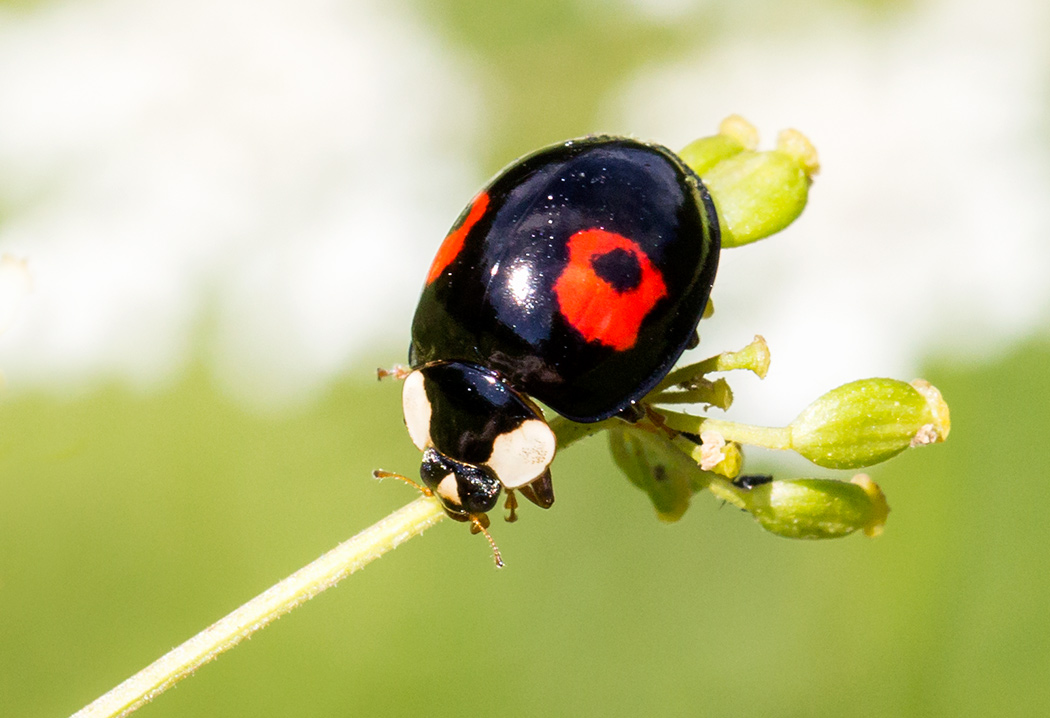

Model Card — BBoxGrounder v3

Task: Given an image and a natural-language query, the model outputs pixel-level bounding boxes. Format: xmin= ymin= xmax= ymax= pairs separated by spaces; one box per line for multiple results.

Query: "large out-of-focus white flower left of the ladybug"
xmin=0 ymin=0 xmax=481 ymax=398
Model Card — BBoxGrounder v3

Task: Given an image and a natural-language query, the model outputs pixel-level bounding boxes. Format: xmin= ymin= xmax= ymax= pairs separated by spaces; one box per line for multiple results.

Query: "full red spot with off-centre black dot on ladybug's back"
xmin=554 ymin=229 xmax=667 ymax=352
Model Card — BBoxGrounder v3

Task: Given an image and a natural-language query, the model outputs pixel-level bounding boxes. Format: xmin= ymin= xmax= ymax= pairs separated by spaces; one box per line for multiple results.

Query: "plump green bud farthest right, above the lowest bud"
xmin=789 ymin=379 xmax=950 ymax=469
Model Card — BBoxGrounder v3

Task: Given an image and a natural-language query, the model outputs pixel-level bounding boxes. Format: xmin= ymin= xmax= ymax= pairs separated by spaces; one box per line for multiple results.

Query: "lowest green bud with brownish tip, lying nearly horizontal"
xmin=742 ymin=473 xmax=889 ymax=539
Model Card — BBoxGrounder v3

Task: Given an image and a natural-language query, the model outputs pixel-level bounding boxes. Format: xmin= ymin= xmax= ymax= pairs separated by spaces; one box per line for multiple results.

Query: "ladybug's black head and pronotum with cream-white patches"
xmin=402 ymin=361 xmax=555 ymax=516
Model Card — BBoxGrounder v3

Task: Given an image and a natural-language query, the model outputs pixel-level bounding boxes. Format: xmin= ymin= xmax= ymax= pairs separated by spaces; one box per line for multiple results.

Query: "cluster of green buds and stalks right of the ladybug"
xmin=592 ymin=117 xmax=951 ymax=539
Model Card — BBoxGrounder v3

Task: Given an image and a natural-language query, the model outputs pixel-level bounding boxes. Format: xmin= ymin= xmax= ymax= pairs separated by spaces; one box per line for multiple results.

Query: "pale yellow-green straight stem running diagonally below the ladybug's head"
xmin=74 ymin=497 xmax=445 ymax=718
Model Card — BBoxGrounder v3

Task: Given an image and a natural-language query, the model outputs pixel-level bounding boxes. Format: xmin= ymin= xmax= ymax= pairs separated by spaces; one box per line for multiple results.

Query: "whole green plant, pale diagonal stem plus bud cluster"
xmin=69 ymin=118 xmax=950 ymax=716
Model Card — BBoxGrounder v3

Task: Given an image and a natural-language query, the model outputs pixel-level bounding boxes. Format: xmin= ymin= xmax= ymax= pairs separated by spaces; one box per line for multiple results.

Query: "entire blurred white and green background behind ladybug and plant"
xmin=0 ymin=0 xmax=1050 ymax=717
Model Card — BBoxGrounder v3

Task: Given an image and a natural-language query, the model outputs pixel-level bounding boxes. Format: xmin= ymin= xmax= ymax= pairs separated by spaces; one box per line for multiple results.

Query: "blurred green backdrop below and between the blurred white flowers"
xmin=0 ymin=0 xmax=1050 ymax=717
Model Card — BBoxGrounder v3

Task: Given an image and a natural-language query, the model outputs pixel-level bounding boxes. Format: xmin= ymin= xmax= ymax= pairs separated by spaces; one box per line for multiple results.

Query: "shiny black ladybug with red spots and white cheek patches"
xmin=401 ymin=136 xmax=720 ymax=530
